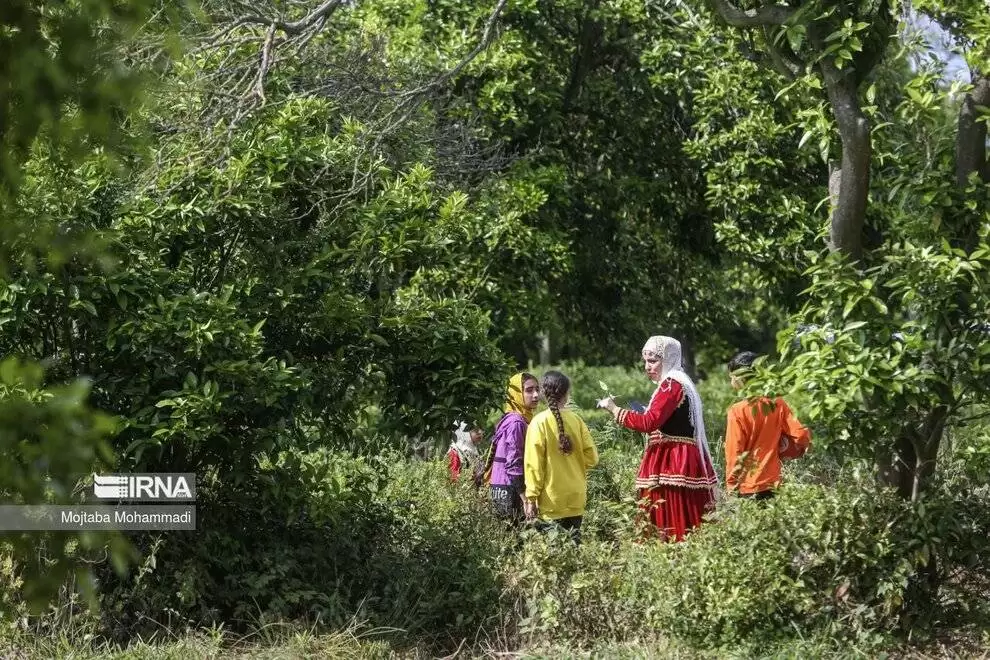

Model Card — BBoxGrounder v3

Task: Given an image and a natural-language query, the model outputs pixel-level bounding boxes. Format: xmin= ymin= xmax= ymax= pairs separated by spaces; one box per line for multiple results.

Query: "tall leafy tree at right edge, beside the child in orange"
xmin=710 ymin=0 xmax=988 ymax=498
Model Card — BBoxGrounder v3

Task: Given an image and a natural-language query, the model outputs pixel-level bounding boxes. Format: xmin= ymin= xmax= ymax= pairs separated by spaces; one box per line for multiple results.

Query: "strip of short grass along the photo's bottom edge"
xmin=0 ymin=604 xmax=990 ymax=660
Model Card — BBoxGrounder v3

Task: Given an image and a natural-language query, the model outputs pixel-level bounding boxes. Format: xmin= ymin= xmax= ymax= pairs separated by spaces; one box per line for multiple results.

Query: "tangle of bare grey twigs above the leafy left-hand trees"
xmin=148 ymin=0 xmax=508 ymax=206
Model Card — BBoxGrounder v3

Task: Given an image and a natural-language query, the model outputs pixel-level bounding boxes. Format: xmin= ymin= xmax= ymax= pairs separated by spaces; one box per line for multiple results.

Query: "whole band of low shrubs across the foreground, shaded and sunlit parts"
xmin=0 ymin=398 xmax=990 ymax=655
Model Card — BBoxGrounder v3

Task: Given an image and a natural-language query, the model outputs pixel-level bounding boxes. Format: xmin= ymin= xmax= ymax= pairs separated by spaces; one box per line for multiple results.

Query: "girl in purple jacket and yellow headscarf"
xmin=489 ymin=372 xmax=540 ymax=524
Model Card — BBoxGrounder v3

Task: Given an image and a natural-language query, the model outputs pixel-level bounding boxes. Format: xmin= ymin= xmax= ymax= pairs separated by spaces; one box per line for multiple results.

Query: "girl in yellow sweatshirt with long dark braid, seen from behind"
xmin=524 ymin=371 xmax=598 ymax=543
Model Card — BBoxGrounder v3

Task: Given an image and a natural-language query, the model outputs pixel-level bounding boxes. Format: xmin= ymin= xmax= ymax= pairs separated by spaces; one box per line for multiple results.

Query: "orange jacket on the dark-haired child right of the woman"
xmin=725 ymin=397 xmax=811 ymax=495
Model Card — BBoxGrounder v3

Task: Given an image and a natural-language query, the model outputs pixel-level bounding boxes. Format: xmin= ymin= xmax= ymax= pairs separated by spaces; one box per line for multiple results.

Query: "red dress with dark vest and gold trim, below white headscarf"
xmin=615 ymin=378 xmax=718 ymax=541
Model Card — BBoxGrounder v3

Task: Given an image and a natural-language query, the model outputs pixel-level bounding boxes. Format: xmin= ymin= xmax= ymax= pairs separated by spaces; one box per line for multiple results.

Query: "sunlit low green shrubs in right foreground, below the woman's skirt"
xmin=513 ymin=471 xmax=990 ymax=648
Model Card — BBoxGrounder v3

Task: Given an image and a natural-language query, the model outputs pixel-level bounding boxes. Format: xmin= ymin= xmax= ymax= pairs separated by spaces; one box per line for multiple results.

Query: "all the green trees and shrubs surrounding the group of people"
xmin=0 ymin=0 xmax=990 ymax=652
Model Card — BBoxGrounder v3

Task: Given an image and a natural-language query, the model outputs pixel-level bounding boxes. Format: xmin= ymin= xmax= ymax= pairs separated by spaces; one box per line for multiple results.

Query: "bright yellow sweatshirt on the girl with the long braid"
xmin=524 ymin=410 xmax=598 ymax=520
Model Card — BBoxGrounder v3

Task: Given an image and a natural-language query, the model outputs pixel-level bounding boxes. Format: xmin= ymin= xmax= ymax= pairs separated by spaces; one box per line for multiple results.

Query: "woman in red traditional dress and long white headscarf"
xmin=598 ymin=336 xmax=718 ymax=541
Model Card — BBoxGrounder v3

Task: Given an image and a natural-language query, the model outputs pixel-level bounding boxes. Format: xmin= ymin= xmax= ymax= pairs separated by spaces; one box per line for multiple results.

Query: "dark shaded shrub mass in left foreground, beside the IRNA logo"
xmin=90 ymin=450 xmax=513 ymax=648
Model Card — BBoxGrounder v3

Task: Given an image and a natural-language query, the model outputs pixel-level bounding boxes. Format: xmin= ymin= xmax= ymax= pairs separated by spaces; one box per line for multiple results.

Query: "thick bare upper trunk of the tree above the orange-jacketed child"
xmin=821 ymin=61 xmax=872 ymax=261
